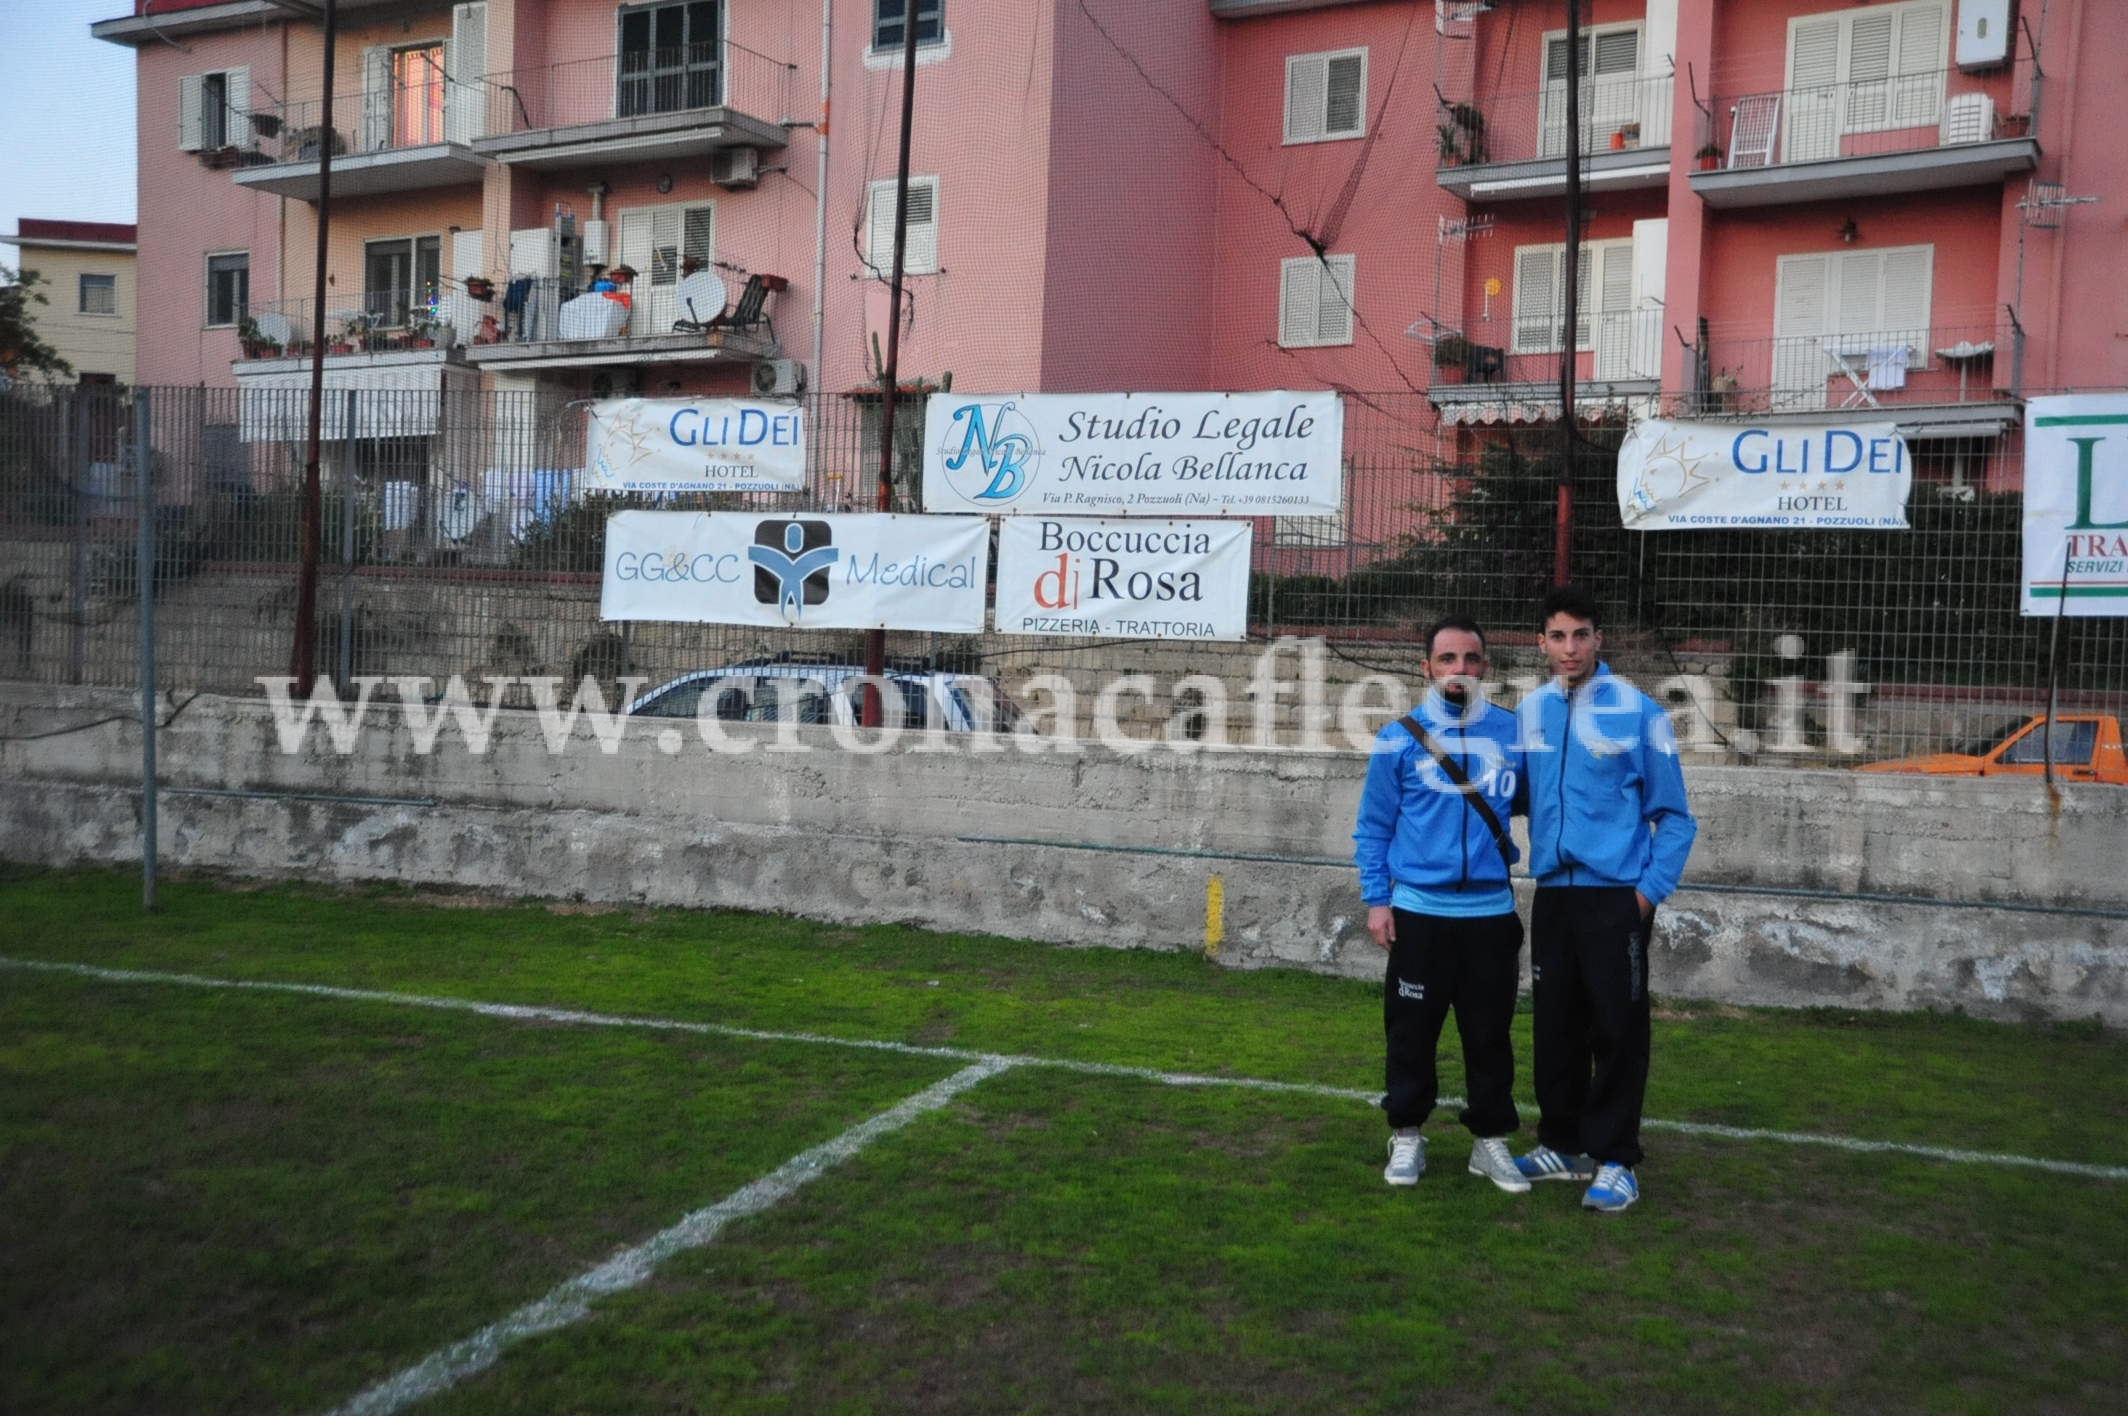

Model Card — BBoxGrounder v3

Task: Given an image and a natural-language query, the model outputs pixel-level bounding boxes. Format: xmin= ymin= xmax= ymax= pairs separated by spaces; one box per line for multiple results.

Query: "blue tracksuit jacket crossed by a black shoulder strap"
xmin=1351 ymin=692 xmax=1524 ymax=905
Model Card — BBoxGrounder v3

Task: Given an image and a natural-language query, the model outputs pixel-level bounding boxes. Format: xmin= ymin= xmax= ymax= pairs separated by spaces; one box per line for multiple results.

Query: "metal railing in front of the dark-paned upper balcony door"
xmin=483 ymin=40 xmax=798 ymax=134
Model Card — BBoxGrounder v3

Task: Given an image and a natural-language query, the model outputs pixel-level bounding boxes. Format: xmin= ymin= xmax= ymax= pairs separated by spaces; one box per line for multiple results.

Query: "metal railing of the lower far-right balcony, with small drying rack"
xmin=1698 ymin=317 xmax=2019 ymax=413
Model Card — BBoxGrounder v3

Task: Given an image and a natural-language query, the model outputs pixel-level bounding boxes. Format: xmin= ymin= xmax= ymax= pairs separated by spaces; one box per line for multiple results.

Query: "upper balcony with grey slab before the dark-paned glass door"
xmin=472 ymin=40 xmax=798 ymax=170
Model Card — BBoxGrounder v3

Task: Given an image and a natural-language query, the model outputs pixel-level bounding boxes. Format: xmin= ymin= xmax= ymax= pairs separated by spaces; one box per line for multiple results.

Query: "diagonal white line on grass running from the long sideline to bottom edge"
xmin=332 ymin=1058 xmax=1011 ymax=1416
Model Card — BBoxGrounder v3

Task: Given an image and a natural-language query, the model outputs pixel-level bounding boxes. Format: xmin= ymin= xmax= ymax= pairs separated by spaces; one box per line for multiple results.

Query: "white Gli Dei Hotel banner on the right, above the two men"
xmin=1617 ymin=417 xmax=1913 ymax=530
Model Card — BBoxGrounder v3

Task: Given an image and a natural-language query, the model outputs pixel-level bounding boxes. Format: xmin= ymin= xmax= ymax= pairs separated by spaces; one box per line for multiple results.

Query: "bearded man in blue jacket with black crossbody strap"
xmin=1351 ymin=618 xmax=1530 ymax=1195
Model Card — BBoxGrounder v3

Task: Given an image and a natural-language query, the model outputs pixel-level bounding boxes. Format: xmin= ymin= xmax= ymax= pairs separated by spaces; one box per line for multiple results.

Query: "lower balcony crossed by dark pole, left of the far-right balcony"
xmin=1426 ymin=307 xmax=1662 ymax=426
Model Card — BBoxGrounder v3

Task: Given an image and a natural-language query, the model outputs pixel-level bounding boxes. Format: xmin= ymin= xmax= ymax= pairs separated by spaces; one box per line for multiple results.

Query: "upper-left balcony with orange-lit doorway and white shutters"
xmin=232 ymin=77 xmax=487 ymax=202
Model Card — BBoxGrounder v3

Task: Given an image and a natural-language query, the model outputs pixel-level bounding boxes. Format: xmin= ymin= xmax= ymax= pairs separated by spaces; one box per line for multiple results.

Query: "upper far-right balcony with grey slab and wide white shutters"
xmin=1692 ymin=60 xmax=2039 ymax=207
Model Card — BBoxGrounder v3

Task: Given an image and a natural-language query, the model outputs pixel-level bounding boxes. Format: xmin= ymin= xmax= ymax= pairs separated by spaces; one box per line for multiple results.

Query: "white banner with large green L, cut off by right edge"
xmin=2019 ymin=394 xmax=2128 ymax=618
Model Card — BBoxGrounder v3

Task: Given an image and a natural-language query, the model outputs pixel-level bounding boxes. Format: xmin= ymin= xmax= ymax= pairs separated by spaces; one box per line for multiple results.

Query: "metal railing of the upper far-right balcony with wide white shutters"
xmin=1711 ymin=60 xmax=2032 ymax=170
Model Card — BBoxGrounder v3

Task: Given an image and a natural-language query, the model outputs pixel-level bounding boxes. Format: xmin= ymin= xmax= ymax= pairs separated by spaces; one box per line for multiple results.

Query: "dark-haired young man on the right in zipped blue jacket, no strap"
xmin=1515 ymin=588 xmax=1698 ymax=1212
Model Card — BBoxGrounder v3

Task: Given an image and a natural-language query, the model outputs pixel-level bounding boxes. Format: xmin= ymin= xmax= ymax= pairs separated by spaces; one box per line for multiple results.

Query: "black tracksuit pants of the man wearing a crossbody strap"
xmin=1381 ymin=909 xmax=1522 ymax=1137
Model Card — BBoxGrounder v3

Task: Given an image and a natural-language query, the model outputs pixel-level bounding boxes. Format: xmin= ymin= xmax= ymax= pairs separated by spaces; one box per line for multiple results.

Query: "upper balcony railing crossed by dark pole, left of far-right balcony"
xmin=1434 ymin=75 xmax=1675 ymax=166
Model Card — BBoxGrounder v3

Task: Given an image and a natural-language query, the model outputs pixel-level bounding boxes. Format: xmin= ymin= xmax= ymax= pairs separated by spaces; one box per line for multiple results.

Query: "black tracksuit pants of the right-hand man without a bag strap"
xmin=1530 ymin=886 xmax=1653 ymax=1165
